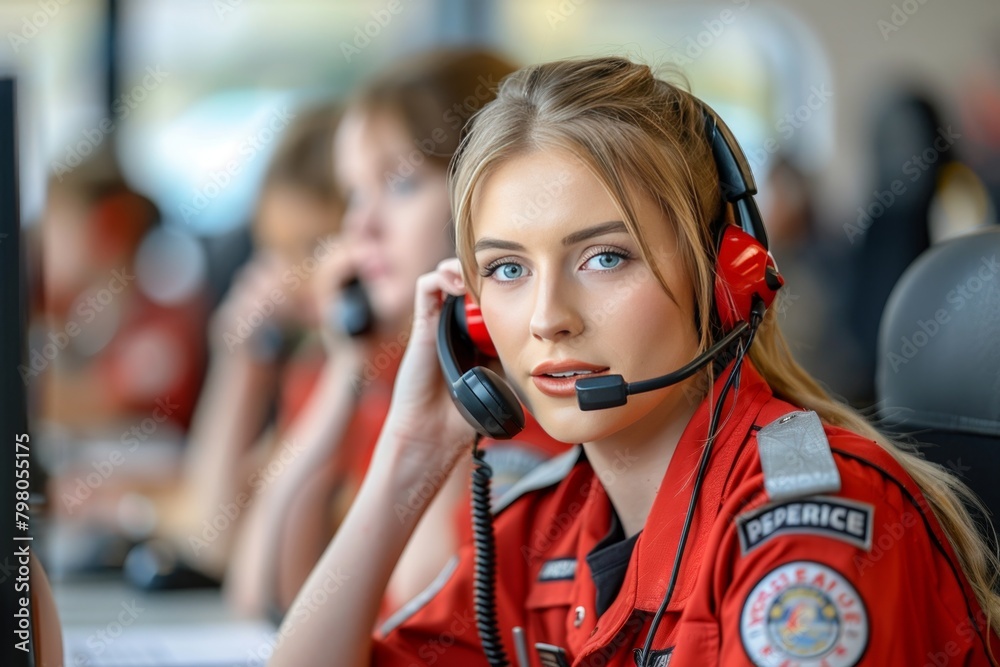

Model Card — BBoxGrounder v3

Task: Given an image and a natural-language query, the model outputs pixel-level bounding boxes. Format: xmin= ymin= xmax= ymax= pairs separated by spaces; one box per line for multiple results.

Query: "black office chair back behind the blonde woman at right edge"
xmin=875 ymin=226 xmax=1000 ymax=532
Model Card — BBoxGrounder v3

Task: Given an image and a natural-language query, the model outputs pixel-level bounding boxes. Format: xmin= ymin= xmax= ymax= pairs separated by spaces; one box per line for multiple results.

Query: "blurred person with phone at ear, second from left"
xmin=127 ymin=104 xmax=344 ymax=588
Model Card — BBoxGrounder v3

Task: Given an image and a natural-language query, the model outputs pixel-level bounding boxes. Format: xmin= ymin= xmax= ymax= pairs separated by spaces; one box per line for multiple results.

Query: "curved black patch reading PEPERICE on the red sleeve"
xmin=736 ymin=496 xmax=875 ymax=554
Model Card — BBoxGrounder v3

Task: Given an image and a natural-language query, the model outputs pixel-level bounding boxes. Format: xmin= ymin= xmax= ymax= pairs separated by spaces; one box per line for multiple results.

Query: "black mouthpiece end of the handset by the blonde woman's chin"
xmin=454 ymin=366 xmax=524 ymax=440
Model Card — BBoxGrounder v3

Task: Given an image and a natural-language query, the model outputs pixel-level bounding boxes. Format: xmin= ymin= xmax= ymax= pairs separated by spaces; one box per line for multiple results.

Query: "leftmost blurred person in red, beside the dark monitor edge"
xmin=36 ymin=145 xmax=204 ymax=436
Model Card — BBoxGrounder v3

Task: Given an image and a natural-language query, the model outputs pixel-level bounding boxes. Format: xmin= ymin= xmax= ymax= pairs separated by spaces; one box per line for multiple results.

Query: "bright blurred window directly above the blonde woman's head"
xmin=497 ymin=0 xmax=833 ymax=179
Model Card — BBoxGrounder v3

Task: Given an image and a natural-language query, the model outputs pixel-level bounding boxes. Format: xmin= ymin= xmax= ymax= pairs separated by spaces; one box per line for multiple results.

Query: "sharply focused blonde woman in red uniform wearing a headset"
xmin=271 ymin=58 xmax=1000 ymax=667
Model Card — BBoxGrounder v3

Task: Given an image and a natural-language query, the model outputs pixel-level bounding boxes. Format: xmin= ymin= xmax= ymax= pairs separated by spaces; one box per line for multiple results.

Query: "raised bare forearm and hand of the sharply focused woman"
xmin=269 ymin=259 xmax=475 ymax=667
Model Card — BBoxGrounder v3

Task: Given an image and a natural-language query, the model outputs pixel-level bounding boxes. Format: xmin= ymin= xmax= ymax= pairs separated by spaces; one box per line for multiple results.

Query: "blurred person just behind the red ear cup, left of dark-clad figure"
xmin=760 ymin=155 xmax=864 ymax=396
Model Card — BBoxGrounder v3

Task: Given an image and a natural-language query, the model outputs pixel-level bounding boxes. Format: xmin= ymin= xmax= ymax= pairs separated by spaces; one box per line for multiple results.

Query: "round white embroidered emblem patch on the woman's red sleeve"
xmin=740 ymin=561 xmax=868 ymax=667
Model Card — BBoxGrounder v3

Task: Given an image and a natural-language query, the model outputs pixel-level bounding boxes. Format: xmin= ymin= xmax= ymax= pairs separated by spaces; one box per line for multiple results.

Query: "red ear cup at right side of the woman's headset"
xmin=715 ymin=225 xmax=785 ymax=331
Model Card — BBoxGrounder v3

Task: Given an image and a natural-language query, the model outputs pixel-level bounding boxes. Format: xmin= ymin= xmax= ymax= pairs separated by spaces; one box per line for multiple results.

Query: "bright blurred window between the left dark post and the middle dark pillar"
xmin=121 ymin=0 xmax=442 ymax=233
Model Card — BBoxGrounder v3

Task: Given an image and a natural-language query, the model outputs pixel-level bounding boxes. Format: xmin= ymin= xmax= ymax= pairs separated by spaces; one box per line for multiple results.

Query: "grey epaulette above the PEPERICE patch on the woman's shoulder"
xmin=757 ymin=411 xmax=840 ymax=502
